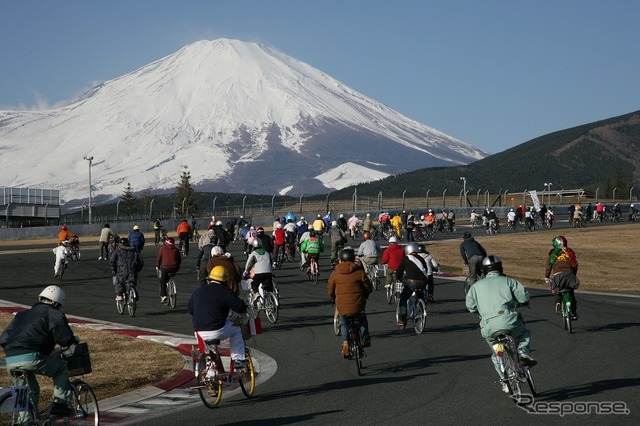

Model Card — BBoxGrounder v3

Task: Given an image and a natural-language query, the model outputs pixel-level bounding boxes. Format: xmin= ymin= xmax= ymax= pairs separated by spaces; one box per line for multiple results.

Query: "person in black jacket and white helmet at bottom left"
xmin=0 ymin=285 xmax=80 ymax=415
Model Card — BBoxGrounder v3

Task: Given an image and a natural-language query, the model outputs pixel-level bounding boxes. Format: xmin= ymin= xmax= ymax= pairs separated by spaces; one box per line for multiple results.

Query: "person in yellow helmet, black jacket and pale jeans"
xmin=187 ymin=266 xmax=247 ymax=368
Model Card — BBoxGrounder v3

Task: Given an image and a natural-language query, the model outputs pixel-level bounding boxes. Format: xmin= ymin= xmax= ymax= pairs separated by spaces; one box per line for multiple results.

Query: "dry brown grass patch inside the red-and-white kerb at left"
xmin=0 ymin=320 xmax=185 ymax=405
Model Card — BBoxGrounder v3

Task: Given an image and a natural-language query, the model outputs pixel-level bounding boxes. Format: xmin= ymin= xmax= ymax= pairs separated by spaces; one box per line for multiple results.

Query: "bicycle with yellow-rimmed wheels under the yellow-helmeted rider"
xmin=189 ymin=339 xmax=256 ymax=408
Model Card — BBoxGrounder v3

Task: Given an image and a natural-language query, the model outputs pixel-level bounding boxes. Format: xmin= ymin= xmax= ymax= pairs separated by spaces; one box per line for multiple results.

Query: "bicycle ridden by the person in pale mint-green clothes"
xmin=492 ymin=330 xmax=536 ymax=404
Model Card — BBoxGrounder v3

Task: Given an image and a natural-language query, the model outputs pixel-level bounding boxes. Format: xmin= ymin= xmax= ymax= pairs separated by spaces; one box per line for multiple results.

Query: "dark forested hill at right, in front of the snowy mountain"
xmin=331 ymin=111 xmax=640 ymax=199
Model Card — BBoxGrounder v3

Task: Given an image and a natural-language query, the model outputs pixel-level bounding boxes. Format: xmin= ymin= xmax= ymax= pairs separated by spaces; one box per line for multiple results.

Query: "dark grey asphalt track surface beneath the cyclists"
xmin=0 ymin=225 xmax=640 ymax=425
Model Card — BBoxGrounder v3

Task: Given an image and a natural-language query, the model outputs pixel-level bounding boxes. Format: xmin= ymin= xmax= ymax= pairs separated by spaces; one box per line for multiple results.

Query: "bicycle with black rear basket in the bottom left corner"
xmin=0 ymin=343 xmax=100 ymax=426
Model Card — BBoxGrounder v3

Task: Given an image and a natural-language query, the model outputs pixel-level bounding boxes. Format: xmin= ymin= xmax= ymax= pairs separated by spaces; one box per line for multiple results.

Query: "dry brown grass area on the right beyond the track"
xmin=428 ymin=224 xmax=640 ymax=292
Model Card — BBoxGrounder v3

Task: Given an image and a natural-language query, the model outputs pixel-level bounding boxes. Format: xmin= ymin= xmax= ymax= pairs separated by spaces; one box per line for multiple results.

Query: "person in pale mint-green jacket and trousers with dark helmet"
xmin=466 ymin=255 xmax=537 ymax=393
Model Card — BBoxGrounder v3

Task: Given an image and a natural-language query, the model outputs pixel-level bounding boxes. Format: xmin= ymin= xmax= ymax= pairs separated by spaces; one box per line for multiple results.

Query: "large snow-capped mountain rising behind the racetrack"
xmin=0 ymin=39 xmax=487 ymax=204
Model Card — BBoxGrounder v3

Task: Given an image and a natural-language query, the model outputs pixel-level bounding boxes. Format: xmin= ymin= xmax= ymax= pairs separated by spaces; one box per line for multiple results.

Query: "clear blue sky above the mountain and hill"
xmin=0 ymin=0 xmax=640 ymax=153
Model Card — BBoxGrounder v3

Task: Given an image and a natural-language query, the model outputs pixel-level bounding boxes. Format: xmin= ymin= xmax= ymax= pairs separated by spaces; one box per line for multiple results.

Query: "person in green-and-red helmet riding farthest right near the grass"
xmin=544 ymin=235 xmax=580 ymax=320
